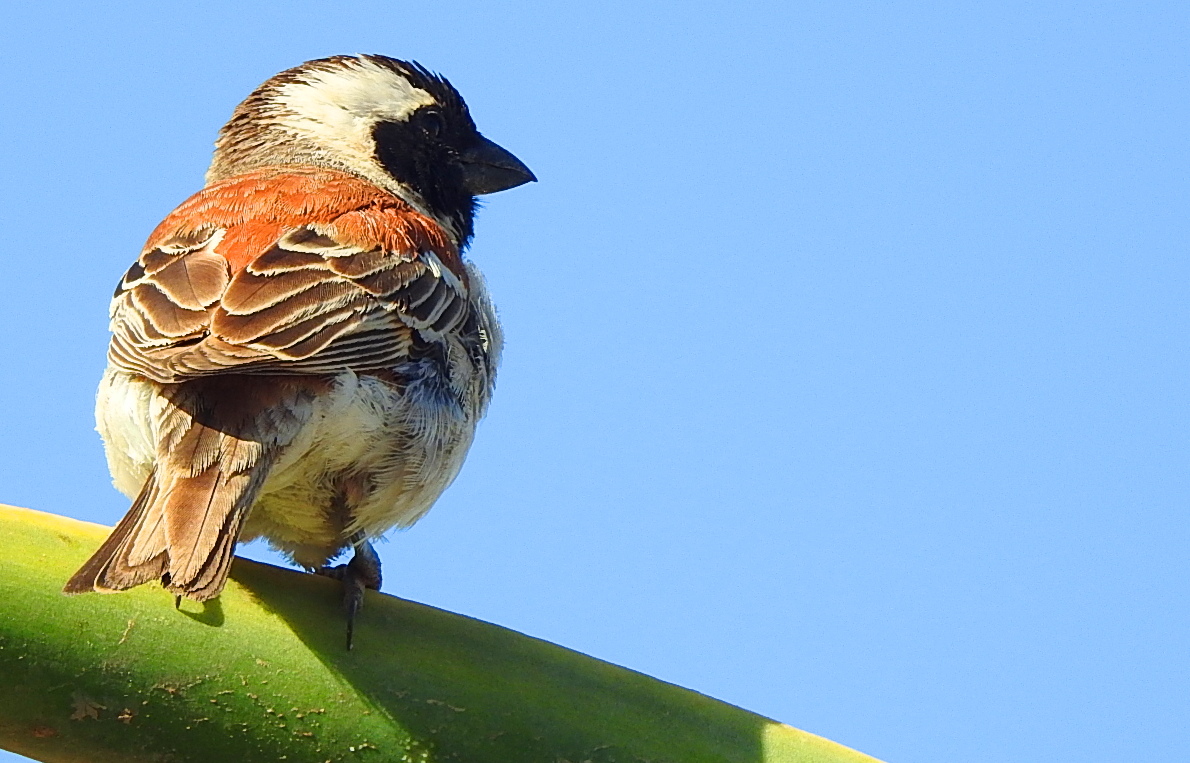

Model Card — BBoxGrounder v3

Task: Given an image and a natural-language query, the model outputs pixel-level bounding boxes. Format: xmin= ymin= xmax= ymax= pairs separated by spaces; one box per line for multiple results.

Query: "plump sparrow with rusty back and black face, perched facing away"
xmin=64 ymin=55 xmax=537 ymax=649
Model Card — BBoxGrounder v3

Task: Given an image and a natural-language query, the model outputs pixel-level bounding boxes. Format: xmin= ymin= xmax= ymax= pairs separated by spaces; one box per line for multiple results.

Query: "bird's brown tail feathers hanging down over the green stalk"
xmin=64 ymin=380 xmax=309 ymax=601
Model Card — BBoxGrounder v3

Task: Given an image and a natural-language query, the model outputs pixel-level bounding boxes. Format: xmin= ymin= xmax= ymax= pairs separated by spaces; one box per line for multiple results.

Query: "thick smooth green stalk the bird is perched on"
xmin=0 ymin=507 xmax=873 ymax=763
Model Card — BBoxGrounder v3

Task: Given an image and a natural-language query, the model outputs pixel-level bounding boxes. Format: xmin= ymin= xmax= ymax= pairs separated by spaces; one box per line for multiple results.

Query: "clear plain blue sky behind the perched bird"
xmin=0 ymin=0 xmax=1190 ymax=763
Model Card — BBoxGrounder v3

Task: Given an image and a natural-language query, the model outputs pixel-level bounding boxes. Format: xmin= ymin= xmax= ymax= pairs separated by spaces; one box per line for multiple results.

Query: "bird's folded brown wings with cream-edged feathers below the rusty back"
xmin=108 ymin=226 xmax=470 ymax=383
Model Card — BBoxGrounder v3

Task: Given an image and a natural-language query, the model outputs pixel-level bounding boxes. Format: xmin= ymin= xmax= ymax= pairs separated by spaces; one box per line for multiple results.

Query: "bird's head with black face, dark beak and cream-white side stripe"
xmin=207 ymin=56 xmax=537 ymax=245
